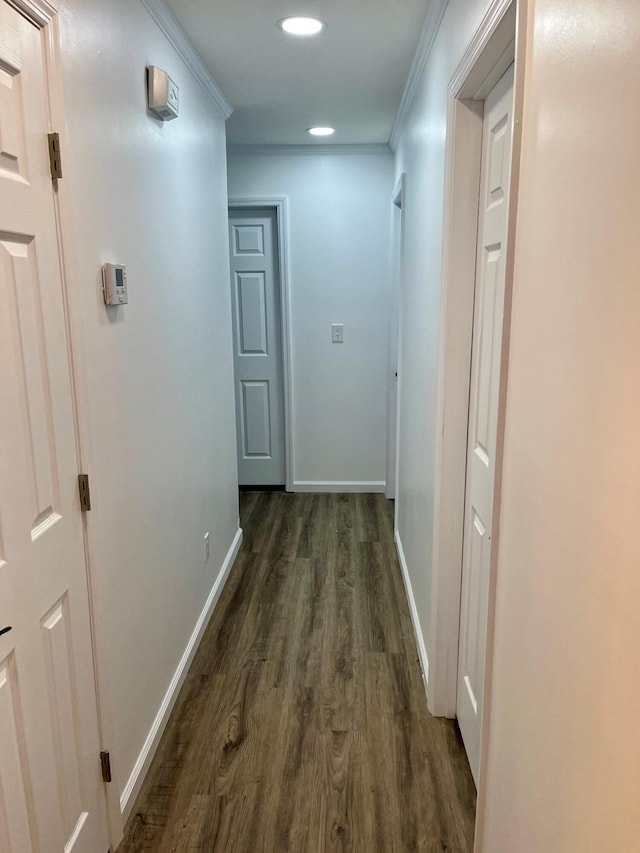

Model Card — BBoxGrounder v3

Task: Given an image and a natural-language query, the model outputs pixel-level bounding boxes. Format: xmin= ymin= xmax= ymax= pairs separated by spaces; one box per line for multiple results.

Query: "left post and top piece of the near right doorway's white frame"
xmin=429 ymin=0 xmax=515 ymax=717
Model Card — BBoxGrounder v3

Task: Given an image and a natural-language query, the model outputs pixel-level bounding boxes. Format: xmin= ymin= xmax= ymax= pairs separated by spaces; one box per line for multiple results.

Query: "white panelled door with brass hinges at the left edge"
xmin=0 ymin=0 xmax=108 ymax=853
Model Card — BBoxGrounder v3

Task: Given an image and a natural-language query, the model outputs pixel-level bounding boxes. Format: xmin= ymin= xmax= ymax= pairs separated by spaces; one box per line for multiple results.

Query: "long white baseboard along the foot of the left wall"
xmin=120 ymin=528 xmax=242 ymax=823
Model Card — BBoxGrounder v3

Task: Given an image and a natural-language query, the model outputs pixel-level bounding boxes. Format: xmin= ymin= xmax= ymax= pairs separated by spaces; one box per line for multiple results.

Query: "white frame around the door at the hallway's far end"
xmin=227 ymin=196 xmax=295 ymax=492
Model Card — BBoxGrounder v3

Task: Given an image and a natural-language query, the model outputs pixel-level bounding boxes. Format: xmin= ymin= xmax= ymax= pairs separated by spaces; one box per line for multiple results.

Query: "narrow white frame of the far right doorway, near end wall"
xmin=385 ymin=172 xmax=406 ymax=506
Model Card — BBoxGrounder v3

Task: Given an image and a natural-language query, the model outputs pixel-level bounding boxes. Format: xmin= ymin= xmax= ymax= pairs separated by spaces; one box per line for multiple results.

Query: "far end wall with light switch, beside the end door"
xmin=229 ymin=154 xmax=393 ymax=490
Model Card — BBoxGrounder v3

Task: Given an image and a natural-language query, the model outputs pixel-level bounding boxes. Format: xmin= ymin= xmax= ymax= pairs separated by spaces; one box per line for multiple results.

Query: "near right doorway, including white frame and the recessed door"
xmin=429 ymin=0 xmax=524 ymax=795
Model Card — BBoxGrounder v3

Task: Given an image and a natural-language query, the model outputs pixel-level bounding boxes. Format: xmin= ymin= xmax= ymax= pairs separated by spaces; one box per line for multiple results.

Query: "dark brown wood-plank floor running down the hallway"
xmin=119 ymin=492 xmax=475 ymax=853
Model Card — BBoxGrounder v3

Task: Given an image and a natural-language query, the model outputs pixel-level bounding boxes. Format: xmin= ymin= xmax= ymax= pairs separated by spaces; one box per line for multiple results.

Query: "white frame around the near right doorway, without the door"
xmin=429 ymin=0 xmax=526 ymax=788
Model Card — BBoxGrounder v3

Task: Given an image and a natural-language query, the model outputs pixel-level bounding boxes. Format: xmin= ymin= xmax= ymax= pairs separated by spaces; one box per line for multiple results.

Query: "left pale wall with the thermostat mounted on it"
xmin=61 ymin=0 xmax=238 ymax=820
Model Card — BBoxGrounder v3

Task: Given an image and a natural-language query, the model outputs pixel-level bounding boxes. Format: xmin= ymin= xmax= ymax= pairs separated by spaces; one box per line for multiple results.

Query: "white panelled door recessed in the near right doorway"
xmin=457 ymin=66 xmax=513 ymax=784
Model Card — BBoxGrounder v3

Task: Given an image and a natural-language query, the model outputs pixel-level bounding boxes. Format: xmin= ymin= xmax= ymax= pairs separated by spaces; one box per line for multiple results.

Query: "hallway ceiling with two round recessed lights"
xmin=162 ymin=0 xmax=429 ymax=145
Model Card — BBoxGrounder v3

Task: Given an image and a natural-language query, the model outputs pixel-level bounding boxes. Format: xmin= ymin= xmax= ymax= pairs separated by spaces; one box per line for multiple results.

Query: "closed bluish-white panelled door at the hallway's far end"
xmin=229 ymin=209 xmax=286 ymax=486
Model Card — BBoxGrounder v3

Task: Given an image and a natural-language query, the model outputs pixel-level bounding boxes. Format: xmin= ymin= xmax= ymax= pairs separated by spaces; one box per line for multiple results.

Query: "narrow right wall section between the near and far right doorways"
xmin=396 ymin=0 xmax=489 ymax=684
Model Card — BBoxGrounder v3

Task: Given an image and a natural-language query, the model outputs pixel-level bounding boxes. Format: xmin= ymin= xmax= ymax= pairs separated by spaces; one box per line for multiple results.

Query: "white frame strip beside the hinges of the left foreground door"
xmin=6 ymin=0 xmax=123 ymax=850
